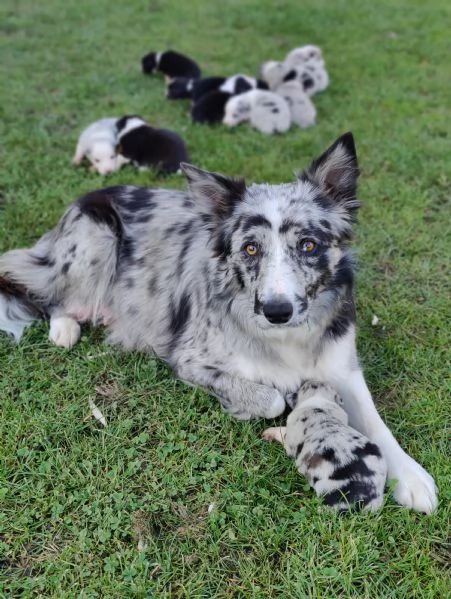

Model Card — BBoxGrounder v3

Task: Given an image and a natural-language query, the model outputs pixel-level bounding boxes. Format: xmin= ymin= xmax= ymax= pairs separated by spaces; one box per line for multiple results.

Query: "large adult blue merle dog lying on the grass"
xmin=0 ymin=133 xmax=437 ymax=513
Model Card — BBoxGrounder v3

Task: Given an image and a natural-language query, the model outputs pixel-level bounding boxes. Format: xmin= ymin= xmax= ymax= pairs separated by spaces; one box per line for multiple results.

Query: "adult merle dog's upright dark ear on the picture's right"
xmin=299 ymin=132 xmax=360 ymax=214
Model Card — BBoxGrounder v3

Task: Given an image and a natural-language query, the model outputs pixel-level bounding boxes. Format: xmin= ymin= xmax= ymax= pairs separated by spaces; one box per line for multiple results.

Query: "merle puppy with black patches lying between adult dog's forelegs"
xmin=263 ymin=382 xmax=387 ymax=510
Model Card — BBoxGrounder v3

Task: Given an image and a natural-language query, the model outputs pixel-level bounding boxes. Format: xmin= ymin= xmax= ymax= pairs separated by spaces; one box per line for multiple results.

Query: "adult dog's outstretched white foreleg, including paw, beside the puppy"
xmin=335 ymin=370 xmax=437 ymax=514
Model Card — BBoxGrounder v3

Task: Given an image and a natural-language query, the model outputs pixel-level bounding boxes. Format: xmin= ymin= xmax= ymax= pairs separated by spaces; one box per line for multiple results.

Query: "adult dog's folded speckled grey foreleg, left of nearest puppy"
xmin=176 ymin=363 xmax=285 ymax=420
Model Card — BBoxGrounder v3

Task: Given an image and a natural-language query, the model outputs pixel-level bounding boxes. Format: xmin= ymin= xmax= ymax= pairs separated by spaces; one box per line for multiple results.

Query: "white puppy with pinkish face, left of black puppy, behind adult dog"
xmin=72 ymin=118 xmax=120 ymax=175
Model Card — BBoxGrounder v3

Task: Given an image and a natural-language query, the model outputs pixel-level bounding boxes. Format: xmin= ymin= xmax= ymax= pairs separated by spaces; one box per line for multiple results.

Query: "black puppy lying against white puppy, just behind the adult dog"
xmin=117 ymin=115 xmax=189 ymax=173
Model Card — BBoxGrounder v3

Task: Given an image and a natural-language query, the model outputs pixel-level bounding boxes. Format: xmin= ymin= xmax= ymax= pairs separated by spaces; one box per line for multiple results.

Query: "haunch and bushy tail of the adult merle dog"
xmin=0 ymin=188 xmax=123 ymax=341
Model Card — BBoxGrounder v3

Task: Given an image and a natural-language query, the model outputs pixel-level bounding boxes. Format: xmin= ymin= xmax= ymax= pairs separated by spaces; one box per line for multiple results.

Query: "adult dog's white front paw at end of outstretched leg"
xmin=389 ymin=455 xmax=438 ymax=514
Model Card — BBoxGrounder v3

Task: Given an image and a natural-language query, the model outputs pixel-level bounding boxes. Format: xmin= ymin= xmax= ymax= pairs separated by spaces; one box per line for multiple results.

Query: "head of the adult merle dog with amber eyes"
xmin=182 ymin=133 xmax=359 ymax=335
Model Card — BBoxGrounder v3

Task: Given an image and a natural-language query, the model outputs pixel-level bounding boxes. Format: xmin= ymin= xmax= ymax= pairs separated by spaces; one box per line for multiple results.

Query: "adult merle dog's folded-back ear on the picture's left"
xmin=180 ymin=162 xmax=246 ymax=220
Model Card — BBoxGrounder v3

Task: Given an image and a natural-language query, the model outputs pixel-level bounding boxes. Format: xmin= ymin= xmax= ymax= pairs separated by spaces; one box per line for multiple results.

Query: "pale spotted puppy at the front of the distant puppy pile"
xmin=222 ymin=89 xmax=291 ymax=134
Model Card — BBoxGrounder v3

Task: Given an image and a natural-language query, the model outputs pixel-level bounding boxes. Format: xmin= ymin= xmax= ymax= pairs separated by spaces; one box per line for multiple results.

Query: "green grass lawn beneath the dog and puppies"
xmin=0 ymin=0 xmax=451 ymax=599
